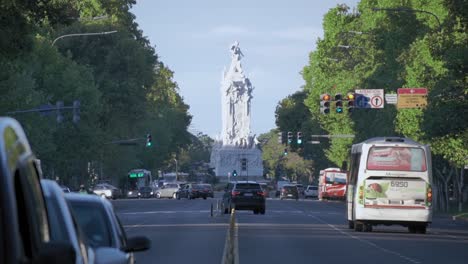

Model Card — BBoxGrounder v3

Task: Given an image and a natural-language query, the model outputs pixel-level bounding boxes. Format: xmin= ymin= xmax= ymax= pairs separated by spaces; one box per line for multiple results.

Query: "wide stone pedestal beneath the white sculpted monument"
xmin=211 ymin=146 xmax=263 ymax=182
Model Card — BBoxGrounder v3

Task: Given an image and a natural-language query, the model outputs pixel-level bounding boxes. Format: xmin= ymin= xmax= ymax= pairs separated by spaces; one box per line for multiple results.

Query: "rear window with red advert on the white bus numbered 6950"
xmin=367 ymin=147 xmax=427 ymax=171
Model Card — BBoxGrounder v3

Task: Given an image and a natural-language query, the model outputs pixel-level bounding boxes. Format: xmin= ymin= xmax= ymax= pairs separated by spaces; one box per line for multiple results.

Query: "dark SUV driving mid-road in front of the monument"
xmin=223 ymin=181 xmax=265 ymax=214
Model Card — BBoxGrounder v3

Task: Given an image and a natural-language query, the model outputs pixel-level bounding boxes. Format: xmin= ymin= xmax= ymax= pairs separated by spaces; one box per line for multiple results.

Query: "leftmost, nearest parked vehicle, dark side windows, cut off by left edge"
xmin=0 ymin=117 xmax=76 ymax=264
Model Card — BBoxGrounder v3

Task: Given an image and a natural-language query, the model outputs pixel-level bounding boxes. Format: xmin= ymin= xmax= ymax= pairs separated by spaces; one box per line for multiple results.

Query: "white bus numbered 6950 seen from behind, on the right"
xmin=346 ymin=137 xmax=432 ymax=233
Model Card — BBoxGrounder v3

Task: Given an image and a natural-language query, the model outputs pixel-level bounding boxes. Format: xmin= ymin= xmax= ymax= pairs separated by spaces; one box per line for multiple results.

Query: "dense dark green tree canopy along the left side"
xmin=0 ymin=0 xmax=191 ymax=190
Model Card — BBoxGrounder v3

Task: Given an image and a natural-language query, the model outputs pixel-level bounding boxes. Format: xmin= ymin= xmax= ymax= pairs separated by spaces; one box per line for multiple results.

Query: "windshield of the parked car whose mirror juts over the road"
xmin=70 ymin=200 xmax=113 ymax=248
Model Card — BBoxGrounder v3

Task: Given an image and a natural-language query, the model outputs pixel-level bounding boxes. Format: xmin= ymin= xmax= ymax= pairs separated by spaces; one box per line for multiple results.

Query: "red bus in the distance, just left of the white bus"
xmin=318 ymin=168 xmax=346 ymax=200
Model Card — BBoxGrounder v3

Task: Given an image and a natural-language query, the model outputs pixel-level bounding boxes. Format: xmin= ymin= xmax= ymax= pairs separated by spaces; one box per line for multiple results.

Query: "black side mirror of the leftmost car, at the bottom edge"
xmin=33 ymin=241 xmax=76 ymax=264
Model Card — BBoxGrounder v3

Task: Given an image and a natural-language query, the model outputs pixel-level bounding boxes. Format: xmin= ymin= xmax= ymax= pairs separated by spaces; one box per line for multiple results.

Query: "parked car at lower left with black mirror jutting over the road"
xmin=65 ymin=193 xmax=151 ymax=264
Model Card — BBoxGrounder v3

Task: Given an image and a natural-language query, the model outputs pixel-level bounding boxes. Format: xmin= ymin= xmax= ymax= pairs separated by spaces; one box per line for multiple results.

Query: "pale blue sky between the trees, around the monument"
xmin=131 ymin=0 xmax=358 ymax=137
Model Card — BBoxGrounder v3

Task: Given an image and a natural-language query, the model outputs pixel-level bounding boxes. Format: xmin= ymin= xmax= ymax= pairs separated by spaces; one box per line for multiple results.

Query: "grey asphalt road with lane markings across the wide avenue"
xmin=113 ymin=195 xmax=468 ymax=264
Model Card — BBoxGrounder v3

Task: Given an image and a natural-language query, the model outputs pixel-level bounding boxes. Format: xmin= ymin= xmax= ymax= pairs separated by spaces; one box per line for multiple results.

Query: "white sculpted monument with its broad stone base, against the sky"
xmin=211 ymin=41 xmax=263 ymax=181
